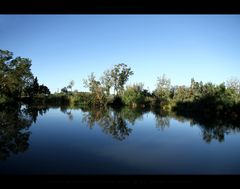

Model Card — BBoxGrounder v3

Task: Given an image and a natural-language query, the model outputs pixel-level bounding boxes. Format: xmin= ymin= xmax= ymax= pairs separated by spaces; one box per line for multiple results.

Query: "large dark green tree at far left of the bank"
xmin=0 ymin=50 xmax=50 ymax=103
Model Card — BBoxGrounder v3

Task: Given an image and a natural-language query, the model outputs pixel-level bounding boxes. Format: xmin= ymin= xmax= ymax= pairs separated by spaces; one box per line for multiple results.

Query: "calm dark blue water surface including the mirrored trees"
xmin=0 ymin=107 xmax=240 ymax=174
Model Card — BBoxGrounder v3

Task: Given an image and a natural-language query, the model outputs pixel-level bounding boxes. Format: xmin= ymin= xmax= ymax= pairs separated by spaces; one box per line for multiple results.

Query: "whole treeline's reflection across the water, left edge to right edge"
xmin=0 ymin=105 xmax=240 ymax=159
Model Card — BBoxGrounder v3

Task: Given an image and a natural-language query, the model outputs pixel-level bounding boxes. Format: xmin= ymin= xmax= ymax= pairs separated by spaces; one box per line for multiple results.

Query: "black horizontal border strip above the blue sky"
xmin=0 ymin=0 xmax=240 ymax=14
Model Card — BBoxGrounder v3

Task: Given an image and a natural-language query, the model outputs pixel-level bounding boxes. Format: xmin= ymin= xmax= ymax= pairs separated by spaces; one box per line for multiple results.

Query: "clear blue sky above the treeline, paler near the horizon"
xmin=0 ymin=15 xmax=240 ymax=92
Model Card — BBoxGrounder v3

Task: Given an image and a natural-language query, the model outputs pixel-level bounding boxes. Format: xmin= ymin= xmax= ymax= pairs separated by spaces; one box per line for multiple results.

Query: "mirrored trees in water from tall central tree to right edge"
xmin=82 ymin=107 xmax=240 ymax=143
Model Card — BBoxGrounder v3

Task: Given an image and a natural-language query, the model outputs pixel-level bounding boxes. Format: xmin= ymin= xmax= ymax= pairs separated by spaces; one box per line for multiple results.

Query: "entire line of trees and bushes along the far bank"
xmin=0 ymin=50 xmax=240 ymax=120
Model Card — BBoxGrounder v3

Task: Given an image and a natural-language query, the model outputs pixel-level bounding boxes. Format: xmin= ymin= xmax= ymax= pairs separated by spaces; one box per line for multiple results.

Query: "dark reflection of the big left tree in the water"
xmin=0 ymin=105 xmax=46 ymax=160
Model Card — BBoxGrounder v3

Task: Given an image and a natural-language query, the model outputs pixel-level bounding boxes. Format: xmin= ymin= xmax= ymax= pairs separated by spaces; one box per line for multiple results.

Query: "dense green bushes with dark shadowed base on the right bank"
xmin=173 ymin=80 xmax=240 ymax=119
